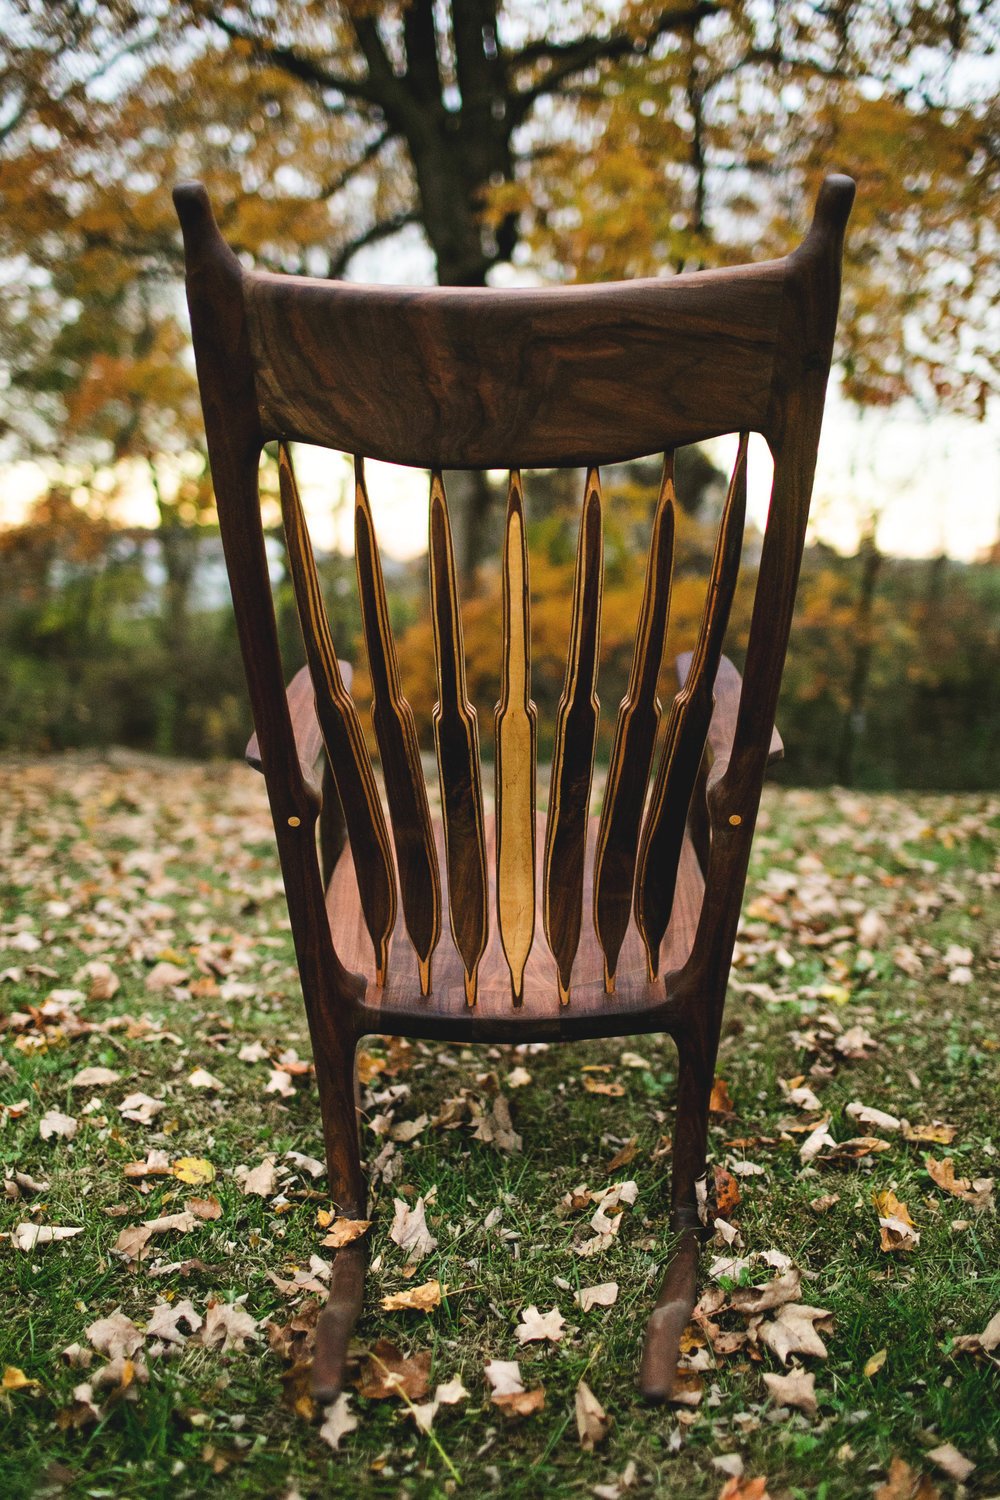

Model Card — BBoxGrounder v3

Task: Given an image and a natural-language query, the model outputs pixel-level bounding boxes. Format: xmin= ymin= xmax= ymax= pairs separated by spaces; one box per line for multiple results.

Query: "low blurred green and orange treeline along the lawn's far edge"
xmin=0 ymin=471 xmax=1000 ymax=789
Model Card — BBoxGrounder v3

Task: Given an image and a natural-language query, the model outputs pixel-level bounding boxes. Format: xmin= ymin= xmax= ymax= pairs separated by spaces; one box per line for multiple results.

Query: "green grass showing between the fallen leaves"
xmin=0 ymin=758 xmax=1000 ymax=1500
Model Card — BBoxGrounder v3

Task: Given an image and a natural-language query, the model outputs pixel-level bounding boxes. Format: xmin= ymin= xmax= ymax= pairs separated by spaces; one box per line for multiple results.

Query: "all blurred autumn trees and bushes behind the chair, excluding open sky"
xmin=0 ymin=0 xmax=1000 ymax=785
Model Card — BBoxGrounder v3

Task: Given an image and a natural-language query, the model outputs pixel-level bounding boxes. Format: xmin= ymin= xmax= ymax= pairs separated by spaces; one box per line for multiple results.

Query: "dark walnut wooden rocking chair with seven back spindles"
xmin=174 ymin=177 xmax=855 ymax=1400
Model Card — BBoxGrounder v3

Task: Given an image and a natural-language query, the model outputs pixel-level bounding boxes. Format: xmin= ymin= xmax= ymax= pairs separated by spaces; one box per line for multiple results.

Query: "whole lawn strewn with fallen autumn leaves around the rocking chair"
xmin=0 ymin=758 xmax=1000 ymax=1500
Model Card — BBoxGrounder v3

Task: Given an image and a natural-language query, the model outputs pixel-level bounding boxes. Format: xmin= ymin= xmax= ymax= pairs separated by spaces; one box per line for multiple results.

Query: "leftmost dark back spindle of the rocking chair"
xmin=277 ymin=444 xmax=396 ymax=983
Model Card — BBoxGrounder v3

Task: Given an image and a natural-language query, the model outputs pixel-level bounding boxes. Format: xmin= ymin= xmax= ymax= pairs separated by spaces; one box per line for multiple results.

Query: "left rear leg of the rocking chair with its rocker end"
xmin=310 ymin=1038 xmax=369 ymax=1404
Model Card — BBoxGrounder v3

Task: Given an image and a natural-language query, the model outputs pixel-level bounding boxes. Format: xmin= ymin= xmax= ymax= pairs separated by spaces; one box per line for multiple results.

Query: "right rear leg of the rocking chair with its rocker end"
xmin=639 ymin=1044 xmax=715 ymax=1401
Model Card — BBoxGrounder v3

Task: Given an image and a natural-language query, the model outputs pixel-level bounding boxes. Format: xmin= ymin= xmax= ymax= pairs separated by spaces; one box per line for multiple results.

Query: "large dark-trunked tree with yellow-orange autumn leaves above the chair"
xmin=0 ymin=0 xmax=1000 ymax=576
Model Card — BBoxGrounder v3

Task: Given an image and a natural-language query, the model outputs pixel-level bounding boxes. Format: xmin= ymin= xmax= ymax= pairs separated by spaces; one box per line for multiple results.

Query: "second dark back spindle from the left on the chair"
xmin=354 ymin=458 xmax=441 ymax=995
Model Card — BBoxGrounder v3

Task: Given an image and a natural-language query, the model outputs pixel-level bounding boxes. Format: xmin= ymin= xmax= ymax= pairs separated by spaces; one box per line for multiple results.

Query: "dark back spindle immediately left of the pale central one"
xmin=429 ymin=473 xmax=489 ymax=1005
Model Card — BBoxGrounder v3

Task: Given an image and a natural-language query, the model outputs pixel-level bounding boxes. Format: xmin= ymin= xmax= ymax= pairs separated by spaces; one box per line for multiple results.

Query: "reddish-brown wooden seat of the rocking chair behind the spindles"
xmin=327 ymin=813 xmax=705 ymax=1040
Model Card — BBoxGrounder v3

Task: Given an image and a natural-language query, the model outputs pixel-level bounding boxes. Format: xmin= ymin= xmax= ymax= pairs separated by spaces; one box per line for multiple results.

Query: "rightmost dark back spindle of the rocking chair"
xmin=636 ymin=432 xmax=747 ymax=977
